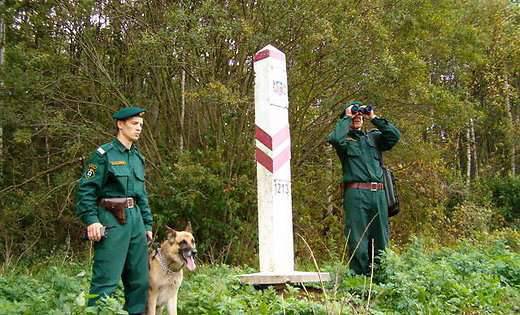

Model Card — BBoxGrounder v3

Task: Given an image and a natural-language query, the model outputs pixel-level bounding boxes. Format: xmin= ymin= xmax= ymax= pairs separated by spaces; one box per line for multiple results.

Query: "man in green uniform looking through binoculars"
xmin=328 ymin=101 xmax=400 ymax=275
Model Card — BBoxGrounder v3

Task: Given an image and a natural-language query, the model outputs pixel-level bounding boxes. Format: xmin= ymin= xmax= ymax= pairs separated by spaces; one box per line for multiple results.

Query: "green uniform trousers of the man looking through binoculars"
xmin=343 ymin=189 xmax=389 ymax=275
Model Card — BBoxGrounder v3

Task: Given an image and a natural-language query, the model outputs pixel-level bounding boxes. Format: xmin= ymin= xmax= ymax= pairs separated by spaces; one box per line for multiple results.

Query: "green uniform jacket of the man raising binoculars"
xmin=328 ymin=116 xmax=400 ymax=183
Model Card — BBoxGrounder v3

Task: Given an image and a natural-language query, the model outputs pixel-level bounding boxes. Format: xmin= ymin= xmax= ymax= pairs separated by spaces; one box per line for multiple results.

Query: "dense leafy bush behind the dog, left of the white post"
xmin=150 ymin=151 xmax=257 ymax=264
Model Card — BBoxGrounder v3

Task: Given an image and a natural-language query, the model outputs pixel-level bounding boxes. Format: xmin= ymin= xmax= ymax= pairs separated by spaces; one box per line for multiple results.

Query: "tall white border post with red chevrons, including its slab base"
xmin=240 ymin=45 xmax=330 ymax=284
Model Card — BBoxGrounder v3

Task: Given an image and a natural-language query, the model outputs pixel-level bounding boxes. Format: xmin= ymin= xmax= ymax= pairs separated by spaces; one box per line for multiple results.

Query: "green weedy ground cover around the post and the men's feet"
xmin=0 ymin=237 xmax=520 ymax=314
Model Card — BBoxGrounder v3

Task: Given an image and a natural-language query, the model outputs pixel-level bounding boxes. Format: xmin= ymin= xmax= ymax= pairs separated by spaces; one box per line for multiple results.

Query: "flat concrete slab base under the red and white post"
xmin=238 ymin=271 xmax=330 ymax=285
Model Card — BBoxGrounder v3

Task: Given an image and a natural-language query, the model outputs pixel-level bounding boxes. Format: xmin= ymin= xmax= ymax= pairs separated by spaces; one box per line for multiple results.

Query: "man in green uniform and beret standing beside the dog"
xmin=76 ymin=107 xmax=152 ymax=314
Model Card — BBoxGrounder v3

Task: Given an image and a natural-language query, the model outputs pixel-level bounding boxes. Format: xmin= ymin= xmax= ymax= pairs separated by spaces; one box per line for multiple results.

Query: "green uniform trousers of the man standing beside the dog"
xmin=88 ymin=206 xmax=148 ymax=314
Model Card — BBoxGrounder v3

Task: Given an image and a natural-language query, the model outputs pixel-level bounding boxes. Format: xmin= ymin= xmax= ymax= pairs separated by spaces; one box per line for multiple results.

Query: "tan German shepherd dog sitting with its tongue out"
xmin=146 ymin=223 xmax=197 ymax=315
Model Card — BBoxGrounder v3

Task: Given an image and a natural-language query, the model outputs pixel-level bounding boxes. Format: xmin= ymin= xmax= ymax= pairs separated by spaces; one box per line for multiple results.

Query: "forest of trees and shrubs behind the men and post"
xmin=0 ymin=0 xmax=520 ymax=270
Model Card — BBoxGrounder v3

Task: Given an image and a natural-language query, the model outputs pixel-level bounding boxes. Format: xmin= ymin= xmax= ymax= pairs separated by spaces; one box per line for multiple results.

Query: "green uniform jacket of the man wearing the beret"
xmin=76 ymin=139 xmax=153 ymax=231
